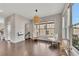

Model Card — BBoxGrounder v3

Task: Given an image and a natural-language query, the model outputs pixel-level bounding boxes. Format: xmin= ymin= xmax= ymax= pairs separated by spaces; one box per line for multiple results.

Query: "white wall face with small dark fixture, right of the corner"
xmin=15 ymin=15 xmax=29 ymax=42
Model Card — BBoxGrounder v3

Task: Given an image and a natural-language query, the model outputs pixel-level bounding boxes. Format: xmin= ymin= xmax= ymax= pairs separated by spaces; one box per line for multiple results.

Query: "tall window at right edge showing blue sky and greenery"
xmin=72 ymin=3 xmax=79 ymax=50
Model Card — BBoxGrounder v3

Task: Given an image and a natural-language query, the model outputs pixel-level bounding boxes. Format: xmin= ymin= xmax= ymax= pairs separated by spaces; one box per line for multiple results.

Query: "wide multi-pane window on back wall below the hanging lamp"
xmin=33 ymin=22 xmax=55 ymax=37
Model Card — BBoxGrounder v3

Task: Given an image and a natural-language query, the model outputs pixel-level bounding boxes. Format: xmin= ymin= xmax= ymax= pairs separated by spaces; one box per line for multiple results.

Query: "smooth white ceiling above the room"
xmin=0 ymin=3 xmax=65 ymax=19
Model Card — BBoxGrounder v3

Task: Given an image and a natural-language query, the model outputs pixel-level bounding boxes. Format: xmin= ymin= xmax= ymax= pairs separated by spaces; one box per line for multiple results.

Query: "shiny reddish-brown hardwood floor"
xmin=0 ymin=40 xmax=60 ymax=56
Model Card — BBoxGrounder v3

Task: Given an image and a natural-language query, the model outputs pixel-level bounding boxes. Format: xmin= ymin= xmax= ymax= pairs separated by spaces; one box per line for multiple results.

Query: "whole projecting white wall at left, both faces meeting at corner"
xmin=4 ymin=14 xmax=30 ymax=43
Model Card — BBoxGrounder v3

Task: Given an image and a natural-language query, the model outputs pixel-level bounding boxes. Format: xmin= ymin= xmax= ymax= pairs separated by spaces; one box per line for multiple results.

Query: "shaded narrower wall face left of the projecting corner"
xmin=4 ymin=14 xmax=15 ymax=40
